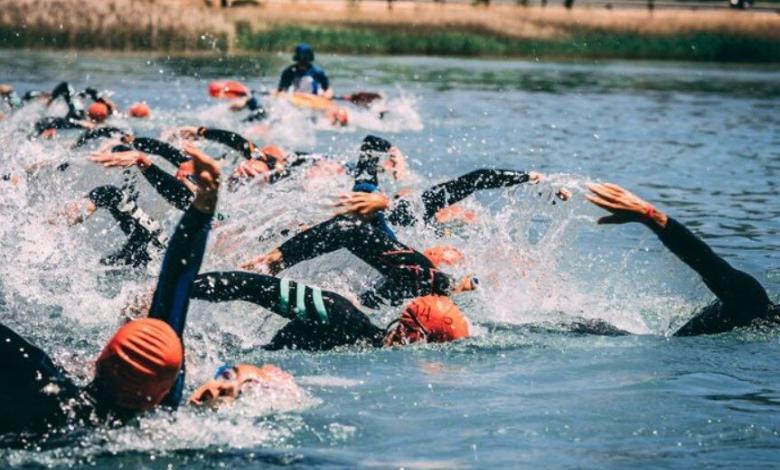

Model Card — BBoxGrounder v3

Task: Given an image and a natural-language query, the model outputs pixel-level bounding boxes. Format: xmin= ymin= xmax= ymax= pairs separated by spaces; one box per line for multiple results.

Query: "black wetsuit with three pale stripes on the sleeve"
xmin=192 ymin=271 xmax=385 ymax=351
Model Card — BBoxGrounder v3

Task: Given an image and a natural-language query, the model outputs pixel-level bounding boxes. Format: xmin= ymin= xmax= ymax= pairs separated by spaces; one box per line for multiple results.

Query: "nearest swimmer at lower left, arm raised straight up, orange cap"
xmin=0 ymin=152 xmax=219 ymax=433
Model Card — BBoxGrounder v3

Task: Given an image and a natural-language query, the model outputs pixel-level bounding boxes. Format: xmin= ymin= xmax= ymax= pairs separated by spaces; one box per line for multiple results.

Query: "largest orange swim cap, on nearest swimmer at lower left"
xmin=95 ymin=318 xmax=184 ymax=411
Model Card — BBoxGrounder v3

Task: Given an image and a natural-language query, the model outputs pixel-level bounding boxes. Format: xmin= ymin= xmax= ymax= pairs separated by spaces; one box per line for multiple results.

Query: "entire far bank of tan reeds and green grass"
xmin=0 ymin=0 xmax=780 ymax=63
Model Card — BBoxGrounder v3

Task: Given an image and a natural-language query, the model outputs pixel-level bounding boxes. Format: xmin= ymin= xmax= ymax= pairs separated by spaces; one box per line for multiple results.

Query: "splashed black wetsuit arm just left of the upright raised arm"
xmin=87 ymin=185 xmax=166 ymax=267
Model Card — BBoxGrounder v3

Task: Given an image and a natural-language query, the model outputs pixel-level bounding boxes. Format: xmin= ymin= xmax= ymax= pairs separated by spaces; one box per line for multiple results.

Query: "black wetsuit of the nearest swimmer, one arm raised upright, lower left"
xmin=0 ymin=209 xmax=211 ymax=434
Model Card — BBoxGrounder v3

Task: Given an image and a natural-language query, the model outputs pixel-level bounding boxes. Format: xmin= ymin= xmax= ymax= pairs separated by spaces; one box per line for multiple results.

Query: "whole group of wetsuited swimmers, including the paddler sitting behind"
xmin=0 ymin=45 xmax=780 ymax=434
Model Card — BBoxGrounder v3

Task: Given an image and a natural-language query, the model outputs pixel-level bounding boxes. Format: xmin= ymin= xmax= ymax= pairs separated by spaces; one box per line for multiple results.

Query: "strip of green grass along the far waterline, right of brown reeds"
xmin=237 ymin=26 xmax=780 ymax=63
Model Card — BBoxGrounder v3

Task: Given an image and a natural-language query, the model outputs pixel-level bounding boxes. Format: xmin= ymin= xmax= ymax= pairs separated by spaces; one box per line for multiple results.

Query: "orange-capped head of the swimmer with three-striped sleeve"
xmin=384 ymin=295 xmax=469 ymax=346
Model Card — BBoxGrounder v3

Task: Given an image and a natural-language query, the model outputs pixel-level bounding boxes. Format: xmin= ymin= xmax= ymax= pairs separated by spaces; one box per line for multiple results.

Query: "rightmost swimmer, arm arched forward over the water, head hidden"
xmin=585 ymin=183 xmax=780 ymax=336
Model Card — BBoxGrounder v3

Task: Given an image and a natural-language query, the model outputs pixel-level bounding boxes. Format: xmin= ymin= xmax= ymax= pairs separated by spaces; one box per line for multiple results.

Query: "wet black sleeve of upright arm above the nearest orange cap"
xmin=149 ymin=207 xmax=212 ymax=408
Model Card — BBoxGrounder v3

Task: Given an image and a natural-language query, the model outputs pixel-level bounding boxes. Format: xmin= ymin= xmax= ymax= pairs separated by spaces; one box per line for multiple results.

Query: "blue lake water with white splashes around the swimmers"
xmin=0 ymin=52 xmax=780 ymax=468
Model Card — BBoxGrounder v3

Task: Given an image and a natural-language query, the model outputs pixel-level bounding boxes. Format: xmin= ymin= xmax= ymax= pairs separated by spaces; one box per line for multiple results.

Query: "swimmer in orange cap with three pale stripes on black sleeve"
xmin=191 ymin=271 xmax=470 ymax=351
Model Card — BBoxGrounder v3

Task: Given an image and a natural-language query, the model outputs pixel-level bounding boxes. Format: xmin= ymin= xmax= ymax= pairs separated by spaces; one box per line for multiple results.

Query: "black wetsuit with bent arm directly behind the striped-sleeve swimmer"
xmin=279 ymin=215 xmax=452 ymax=307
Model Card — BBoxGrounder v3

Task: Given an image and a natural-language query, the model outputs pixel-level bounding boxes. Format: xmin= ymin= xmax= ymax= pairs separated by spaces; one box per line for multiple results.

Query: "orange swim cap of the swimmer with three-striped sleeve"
xmin=401 ymin=295 xmax=469 ymax=343
